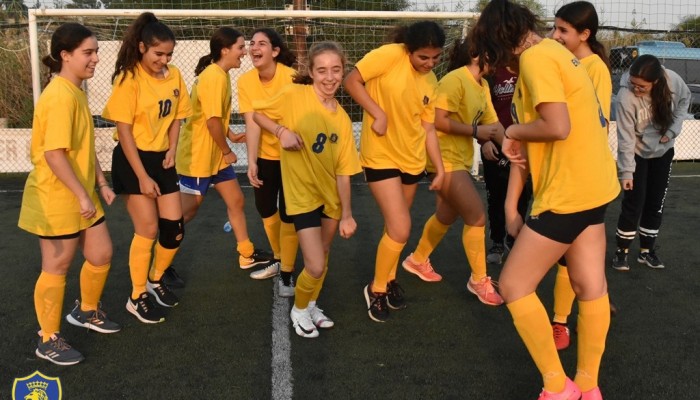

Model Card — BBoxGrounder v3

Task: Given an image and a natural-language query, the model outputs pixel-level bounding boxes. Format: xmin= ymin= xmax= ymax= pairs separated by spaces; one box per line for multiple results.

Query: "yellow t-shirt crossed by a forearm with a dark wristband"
xmin=426 ymin=67 xmax=498 ymax=172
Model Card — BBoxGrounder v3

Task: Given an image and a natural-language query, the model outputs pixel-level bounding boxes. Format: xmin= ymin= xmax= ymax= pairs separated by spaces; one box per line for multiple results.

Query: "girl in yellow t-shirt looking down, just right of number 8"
xmin=345 ymin=21 xmax=445 ymax=322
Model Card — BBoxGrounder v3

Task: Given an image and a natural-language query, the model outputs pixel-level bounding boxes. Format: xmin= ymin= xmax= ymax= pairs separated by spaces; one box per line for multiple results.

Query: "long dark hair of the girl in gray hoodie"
xmin=630 ymin=54 xmax=673 ymax=136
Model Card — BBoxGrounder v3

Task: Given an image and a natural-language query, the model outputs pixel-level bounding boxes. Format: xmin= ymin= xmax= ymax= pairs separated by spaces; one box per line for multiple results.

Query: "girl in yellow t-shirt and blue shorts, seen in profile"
xmin=175 ymin=27 xmax=272 ymax=282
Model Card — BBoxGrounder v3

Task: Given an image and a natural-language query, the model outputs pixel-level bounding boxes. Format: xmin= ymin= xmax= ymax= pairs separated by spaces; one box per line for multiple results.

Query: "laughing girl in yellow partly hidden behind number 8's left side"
xmin=238 ymin=28 xmax=299 ymax=284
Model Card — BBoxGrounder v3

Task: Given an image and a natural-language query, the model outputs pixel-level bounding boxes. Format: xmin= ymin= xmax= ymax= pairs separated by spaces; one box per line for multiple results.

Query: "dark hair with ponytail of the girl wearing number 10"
xmin=112 ymin=12 xmax=175 ymax=82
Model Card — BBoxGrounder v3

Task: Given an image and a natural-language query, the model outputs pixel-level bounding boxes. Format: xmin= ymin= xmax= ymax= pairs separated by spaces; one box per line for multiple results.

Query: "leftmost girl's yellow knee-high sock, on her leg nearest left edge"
xmin=34 ymin=271 xmax=66 ymax=342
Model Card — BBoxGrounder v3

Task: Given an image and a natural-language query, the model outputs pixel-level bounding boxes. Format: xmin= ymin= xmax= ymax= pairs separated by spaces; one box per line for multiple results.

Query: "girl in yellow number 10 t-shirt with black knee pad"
xmin=102 ymin=12 xmax=192 ymax=324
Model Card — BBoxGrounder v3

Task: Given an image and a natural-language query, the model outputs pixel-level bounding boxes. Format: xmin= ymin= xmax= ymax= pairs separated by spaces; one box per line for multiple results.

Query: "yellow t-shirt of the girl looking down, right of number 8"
xmin=355 ymin=44 xmax=437 ymax=175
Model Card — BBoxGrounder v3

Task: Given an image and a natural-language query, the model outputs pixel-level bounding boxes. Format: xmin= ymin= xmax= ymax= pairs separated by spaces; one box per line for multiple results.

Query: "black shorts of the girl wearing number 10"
xmin=112 ymin=144 xmax=180 ymax=195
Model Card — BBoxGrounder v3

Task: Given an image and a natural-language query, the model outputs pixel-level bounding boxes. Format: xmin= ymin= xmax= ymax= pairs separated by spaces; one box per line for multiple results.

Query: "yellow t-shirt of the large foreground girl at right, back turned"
xmin=513 ymin=39 xmax=620 ymax=215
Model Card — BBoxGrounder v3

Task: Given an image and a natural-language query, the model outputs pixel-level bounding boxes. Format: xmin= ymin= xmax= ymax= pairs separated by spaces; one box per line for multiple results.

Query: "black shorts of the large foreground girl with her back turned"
xmin=526 ymin=204 xmax=608 ymax=244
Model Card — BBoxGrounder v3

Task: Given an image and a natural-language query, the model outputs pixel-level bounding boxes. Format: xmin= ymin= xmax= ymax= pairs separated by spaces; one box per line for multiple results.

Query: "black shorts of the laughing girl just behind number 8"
xmin=253 ymin=158 xmax=294 ymax=224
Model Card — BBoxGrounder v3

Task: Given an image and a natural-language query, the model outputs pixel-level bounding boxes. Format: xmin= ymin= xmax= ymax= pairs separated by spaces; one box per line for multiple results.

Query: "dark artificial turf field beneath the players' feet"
xmin=0 ymin=163 xmax=700 ymax=400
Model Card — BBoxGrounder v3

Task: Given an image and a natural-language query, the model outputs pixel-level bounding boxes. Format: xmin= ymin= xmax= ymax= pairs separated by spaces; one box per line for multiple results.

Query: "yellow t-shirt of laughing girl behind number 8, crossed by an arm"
xmin=238 ymin=63 xmax=296 ymax=160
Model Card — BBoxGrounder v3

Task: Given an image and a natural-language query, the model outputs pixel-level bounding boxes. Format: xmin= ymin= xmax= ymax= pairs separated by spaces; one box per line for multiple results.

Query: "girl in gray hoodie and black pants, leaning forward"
xmin=612 ymin=55 xmax=690 ymax=271
